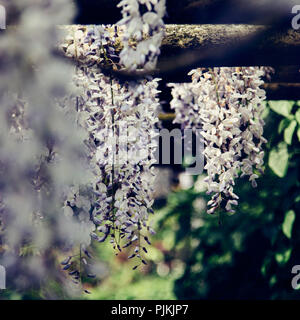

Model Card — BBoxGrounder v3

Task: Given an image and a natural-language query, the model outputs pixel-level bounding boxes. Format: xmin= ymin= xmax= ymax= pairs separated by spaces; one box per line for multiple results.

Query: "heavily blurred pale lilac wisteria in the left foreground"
xmin=0 ymin=0 xmax=96 ymax=296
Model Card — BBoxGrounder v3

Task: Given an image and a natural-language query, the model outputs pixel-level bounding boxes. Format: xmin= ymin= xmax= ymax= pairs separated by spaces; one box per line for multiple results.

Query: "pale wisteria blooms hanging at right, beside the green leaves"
xmin=170 ymin=67 xmax=267 ymax=214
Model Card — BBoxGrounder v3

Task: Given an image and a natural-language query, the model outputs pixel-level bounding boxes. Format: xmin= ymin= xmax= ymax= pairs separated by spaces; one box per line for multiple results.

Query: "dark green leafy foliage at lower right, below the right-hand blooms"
xmin=152 ymin=101 xmax=300 ymax=299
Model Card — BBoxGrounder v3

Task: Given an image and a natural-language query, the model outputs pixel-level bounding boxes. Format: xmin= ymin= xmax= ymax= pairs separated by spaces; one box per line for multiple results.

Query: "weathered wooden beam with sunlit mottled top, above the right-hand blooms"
xmin=58 ymin=25 xmax=300 ymax=82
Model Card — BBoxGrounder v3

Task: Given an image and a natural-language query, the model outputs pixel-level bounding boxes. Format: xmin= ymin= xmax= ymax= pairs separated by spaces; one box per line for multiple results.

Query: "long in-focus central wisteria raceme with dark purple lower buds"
xmin=63 ymin=26 xmax=159 ymax=264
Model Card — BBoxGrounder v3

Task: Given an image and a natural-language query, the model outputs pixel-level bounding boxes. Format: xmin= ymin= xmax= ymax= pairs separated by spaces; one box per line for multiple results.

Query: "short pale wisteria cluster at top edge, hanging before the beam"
xmin=118 ymin=0 xmax=166 ymax=70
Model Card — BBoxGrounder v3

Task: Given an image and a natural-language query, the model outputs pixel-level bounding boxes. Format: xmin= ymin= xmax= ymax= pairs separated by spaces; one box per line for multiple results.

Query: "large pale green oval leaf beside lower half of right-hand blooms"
xmin=268 ymin=142 xmax=289 ymax=178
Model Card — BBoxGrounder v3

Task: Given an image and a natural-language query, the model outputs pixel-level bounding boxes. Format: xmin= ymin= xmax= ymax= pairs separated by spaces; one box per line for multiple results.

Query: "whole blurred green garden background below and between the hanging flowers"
xmin=5 ymin=101 xmax=300 ymax=300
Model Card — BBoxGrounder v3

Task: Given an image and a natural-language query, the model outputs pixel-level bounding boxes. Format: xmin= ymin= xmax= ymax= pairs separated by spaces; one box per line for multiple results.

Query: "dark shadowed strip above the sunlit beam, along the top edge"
xmin=75 ymin=0 xmax=292 ymax=24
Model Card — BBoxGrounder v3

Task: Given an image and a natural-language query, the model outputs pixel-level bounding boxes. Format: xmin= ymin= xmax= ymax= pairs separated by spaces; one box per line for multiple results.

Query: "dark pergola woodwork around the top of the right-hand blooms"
xmin=59 ymin=20 xmax=300 ymax=121
